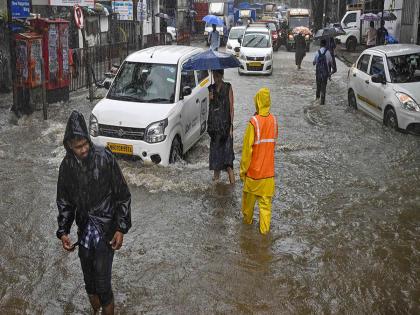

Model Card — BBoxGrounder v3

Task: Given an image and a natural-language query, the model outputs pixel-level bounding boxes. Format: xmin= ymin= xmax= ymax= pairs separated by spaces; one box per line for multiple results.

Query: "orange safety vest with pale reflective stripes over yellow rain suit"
xmin=246 ymin=114 xmax=278 ymax=179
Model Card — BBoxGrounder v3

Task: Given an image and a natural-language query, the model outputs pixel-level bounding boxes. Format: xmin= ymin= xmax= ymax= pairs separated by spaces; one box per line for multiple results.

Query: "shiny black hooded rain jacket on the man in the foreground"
xmin=56 ymin=111 xmax=131 ymax=241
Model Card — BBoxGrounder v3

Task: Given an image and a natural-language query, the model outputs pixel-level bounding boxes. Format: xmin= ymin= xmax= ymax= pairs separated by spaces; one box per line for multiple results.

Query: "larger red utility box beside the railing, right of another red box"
xmin=30 ymin=18 xmax=70 ymax=103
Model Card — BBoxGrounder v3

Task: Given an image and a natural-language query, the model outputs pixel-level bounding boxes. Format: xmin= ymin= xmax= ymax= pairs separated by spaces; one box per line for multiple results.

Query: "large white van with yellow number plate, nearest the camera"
xmin=89 ymin=46 xmax=209 ymax=166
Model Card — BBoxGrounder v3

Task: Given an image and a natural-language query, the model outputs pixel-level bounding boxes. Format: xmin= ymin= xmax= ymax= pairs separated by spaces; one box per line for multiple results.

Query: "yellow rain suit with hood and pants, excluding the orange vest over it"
xmin=239 ymin=90 xmax=275 ymax=234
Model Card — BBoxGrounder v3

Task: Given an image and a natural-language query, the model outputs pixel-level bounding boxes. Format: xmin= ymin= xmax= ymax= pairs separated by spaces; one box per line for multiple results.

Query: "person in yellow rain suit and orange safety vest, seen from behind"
xmin=240 ymin=88 xmax=278 ymax=234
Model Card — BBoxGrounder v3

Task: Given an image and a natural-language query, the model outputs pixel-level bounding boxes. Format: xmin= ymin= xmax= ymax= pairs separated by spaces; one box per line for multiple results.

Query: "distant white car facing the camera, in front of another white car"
xmin=238 ymin=26 xmax=273 ymax=74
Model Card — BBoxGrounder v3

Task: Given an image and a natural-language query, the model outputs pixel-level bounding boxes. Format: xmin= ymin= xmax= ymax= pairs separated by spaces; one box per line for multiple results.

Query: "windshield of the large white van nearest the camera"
xmin=107 ymin=61 xmax=176 ymax=103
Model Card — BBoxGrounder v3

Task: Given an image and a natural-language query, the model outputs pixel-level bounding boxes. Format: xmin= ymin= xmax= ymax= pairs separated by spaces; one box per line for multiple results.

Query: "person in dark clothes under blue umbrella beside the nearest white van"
xmin=207 ymin=70 xmax=235 ymax=184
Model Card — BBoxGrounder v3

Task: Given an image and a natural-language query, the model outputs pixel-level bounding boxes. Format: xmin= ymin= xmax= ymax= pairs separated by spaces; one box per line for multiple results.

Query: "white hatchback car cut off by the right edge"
xmin=348 ymin=44 xmax=420 ymax=133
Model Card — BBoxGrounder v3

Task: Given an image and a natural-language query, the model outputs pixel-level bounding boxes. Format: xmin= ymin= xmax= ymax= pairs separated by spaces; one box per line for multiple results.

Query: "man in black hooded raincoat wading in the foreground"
xmin=56 ymin=111 xmax=131 ymax=314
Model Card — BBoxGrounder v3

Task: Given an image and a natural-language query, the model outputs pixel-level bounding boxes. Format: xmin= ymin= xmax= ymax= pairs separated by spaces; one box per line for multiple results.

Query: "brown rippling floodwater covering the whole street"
xmin=0 ymin=43 xmax=420 ymax=314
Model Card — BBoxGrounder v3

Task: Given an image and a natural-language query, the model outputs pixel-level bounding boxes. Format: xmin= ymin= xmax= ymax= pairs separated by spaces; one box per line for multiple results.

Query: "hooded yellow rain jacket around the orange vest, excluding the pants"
xmin=239 ymin=88 xmax=274 ymax=196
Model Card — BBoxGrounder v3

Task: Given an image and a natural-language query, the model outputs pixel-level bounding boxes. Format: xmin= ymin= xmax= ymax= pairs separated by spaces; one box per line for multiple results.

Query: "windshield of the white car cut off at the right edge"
xmin=387 ymin=53 xmax=420 ymax=83
